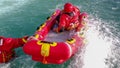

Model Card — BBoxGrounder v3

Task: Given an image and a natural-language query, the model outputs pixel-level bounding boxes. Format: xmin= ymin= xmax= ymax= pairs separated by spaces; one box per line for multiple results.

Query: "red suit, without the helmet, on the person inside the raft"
xmin=57 ymin=6 xmax=80 ymax=32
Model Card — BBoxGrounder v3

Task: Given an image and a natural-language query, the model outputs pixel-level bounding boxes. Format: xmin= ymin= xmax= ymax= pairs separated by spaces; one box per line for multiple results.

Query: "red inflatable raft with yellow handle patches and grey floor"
xmin=23 ymin=10 xmax=87 ymax=64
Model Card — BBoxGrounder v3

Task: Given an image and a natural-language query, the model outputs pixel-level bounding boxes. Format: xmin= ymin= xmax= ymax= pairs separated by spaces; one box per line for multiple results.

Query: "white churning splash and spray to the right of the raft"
xmin=83 ymin=14 xmax=120 ymax=68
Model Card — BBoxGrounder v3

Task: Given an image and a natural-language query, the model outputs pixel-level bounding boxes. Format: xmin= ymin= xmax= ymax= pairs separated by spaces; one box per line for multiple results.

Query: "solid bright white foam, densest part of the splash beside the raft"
xmin=83 ymin=26 xmax=111 ymax=68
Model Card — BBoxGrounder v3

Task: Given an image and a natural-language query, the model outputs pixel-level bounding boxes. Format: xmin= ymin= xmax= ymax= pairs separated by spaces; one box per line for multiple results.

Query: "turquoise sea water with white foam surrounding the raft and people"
xmin=0 ymin=0 xmax=120 ymax=68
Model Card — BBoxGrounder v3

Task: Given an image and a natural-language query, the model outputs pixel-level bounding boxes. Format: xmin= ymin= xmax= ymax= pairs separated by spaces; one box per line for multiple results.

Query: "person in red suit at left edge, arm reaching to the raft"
xmin=0 ymin=36 xmax=28 ymax=63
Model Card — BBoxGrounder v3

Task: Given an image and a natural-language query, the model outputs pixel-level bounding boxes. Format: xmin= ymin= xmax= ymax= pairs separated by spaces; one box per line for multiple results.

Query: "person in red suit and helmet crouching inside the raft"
xmin=53 ymin=2 xmax=80 ymax=32
